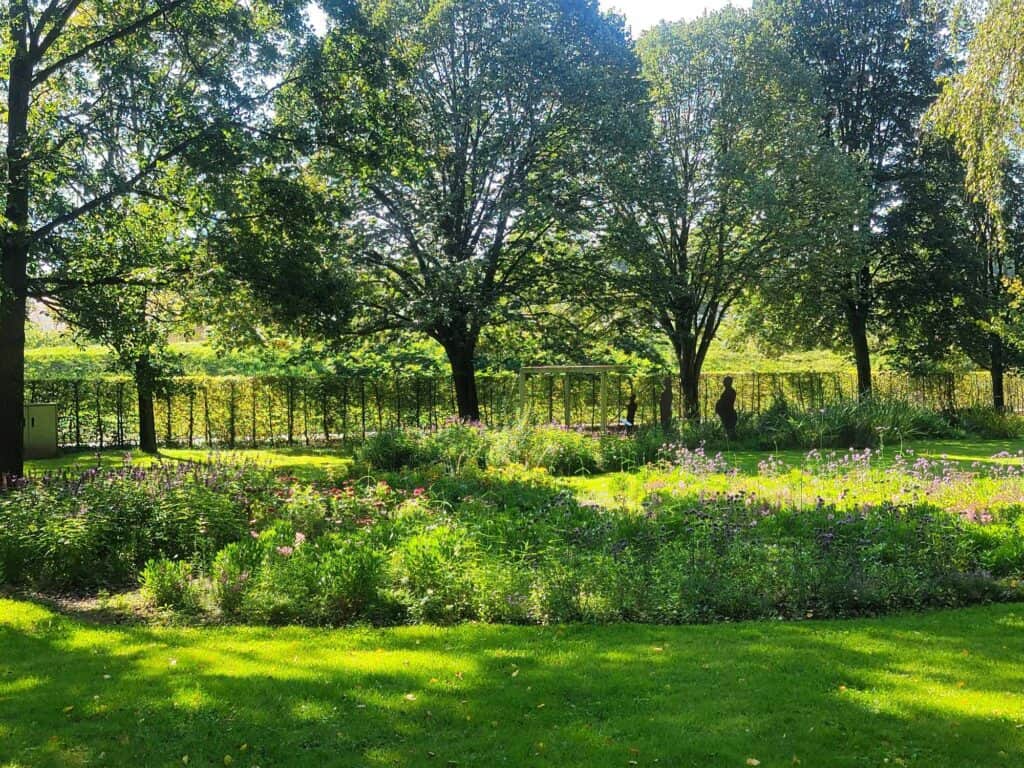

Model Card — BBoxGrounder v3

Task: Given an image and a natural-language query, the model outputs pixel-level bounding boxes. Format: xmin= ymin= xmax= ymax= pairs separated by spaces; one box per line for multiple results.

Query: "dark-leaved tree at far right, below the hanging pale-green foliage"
xmin=888 ymin=141 xmax=1024 ymax=411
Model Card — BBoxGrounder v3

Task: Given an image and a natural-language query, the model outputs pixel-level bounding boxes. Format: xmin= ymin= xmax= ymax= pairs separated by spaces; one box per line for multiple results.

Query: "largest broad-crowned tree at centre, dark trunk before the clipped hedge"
xmin=230 ymin=0 xmax=638 ymax=420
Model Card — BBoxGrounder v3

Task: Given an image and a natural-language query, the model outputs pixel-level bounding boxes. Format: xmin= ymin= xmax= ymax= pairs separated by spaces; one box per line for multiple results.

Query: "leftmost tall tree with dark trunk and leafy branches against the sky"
xmin=0 ymin=0 xmax=302 ymax=474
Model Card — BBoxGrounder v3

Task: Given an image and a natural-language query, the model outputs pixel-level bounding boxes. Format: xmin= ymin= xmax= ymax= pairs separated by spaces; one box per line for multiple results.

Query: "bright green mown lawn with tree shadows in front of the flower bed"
xmin=0 ymin=600 xmax=1024 ymax=768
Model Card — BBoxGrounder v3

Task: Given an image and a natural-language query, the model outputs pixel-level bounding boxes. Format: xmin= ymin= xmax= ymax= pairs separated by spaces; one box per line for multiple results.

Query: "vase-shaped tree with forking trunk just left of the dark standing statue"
xmin=604 ymin=9 xmax=859 ymax=418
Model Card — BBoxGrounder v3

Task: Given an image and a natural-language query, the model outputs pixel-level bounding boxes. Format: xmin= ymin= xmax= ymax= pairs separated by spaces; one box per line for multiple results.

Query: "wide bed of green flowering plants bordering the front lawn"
xmin=8 ymin=448 xmax=1024 ymax=626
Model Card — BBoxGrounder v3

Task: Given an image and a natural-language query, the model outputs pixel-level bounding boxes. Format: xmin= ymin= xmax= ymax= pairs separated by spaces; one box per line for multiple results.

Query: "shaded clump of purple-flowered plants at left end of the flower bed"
xmin=0 ymin=464 xmax=272 ymax=590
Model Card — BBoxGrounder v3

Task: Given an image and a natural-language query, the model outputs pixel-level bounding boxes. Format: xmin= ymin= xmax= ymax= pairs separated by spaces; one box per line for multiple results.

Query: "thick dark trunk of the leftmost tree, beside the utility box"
xmin=0 ymin=13 xmax=32 ymax=475
